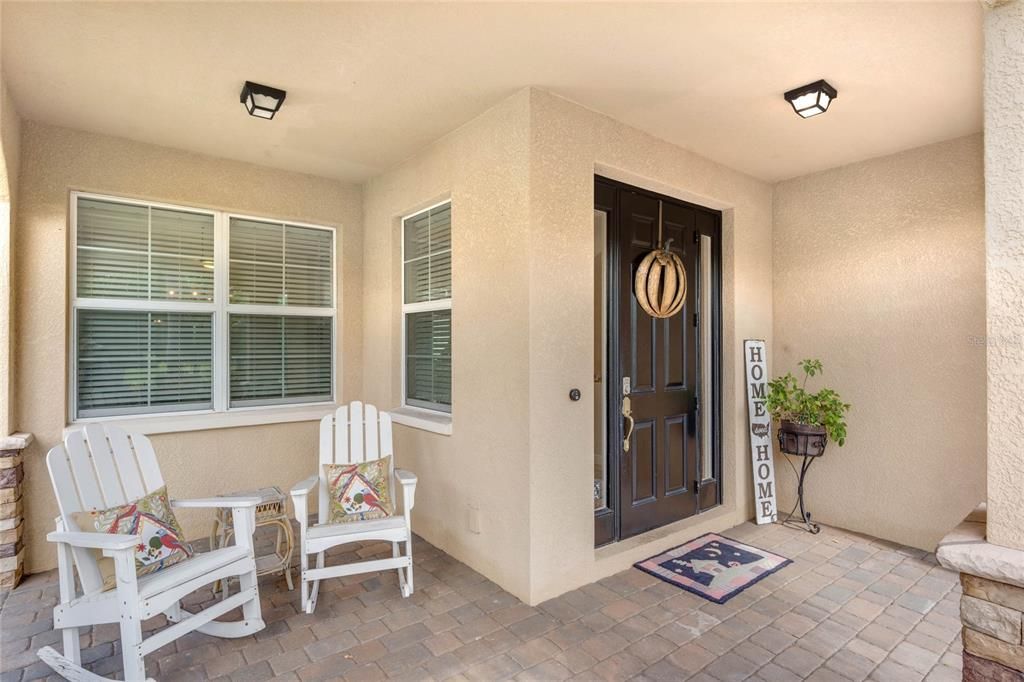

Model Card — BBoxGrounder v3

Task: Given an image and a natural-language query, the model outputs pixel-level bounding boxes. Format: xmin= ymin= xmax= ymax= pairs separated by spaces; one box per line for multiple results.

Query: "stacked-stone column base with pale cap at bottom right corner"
xmin=935 ymin=505 xmax=1024 ymax=682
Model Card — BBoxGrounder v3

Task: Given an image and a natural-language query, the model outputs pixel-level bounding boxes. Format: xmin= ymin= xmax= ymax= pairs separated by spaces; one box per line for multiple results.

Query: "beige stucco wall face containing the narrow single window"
xmin=364 ymin=91 xmax=530 ymax=599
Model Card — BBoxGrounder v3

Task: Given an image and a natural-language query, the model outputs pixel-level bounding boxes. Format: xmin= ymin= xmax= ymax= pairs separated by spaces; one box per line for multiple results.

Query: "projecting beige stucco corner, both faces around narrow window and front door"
xmin=364 ymin=89 xmax=771 ymax=603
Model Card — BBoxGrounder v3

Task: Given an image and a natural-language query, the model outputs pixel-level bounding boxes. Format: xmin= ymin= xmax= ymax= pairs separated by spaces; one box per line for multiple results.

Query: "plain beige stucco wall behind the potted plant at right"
xmin=772 ymin=134 xmax=987 ymax=550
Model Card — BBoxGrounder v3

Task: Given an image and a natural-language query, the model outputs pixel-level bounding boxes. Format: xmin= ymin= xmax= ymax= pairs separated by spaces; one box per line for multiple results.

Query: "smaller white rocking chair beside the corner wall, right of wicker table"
xmin=292 ymin=401 xmax=416 ymax=613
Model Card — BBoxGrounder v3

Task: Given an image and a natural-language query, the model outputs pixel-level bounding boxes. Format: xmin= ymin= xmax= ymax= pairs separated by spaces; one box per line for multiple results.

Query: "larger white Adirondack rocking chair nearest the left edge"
xmin=38 ymin=424 xmax=264 ymax=680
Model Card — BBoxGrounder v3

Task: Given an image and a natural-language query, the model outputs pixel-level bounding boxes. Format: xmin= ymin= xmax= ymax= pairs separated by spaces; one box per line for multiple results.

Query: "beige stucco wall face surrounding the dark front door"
xmin=528 ymin=90 xmax=772 ymax=602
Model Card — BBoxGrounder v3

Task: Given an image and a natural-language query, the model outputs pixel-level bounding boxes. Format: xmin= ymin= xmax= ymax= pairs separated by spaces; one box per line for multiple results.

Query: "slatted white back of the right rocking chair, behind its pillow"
xmin=318 ymin=400 xmax=394 ymax=523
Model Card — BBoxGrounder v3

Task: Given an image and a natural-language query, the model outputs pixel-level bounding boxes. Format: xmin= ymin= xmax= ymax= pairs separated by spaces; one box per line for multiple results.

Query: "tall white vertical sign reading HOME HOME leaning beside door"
xmin=743 ymin=339 xmax=778 ymax=525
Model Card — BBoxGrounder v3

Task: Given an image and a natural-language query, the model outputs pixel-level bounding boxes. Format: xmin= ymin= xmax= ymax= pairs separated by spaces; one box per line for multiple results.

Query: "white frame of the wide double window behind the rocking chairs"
xmin=65 ymin=191 xmax=340 ymax=433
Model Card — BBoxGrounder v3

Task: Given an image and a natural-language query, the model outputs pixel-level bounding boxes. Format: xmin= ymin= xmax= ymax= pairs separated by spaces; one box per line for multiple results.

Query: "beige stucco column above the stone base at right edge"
xmin=984 ymin=0 xmax=1024 ymax=550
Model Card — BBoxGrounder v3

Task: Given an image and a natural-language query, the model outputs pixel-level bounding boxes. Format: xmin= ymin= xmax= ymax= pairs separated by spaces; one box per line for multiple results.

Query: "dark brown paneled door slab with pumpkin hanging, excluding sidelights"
xmin=611 ymin=191 xmax=698 ymax=538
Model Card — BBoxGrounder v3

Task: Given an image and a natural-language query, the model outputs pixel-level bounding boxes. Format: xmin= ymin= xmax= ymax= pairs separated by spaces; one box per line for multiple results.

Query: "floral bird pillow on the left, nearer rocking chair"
xmin=78 ymin=487 xmax=195 ymax=578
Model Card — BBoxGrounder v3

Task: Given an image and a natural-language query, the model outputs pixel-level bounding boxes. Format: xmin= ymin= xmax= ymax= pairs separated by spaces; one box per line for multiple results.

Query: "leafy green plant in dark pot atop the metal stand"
xmin=765 ymin=359 xmax=850 ymax=457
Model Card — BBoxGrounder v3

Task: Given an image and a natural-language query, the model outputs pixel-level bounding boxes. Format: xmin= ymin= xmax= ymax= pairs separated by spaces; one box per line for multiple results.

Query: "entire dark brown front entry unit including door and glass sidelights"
xmin=594 ymin=177 xmax=723 ymax=545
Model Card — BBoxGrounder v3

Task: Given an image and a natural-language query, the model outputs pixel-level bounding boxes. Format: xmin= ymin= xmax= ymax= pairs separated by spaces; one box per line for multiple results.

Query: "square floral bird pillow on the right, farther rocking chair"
xmin=324 ymin=455 xmax=394 ymax=523
